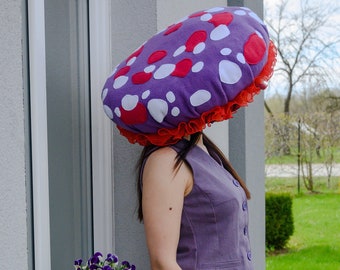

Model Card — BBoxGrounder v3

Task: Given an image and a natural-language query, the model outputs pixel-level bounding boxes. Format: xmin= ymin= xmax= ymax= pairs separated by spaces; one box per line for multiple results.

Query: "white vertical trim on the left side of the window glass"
xmin=28 ymin=0 xmax=51 ymax=270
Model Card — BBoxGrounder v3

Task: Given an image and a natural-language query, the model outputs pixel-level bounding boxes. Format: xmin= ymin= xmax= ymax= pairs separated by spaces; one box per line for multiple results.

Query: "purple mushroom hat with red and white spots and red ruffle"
xmin=102 ymin=7 xmax=276 ymax=146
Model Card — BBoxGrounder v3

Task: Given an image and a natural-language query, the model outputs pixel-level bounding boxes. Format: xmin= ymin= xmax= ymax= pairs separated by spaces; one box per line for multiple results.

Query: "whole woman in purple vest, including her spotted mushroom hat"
xmin=102 ymin=7 xmax=276 ymax=270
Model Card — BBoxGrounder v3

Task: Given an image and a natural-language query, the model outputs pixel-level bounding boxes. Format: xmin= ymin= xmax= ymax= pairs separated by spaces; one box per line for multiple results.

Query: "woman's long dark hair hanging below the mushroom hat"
xmin=136 ymin=132 xmax=250 ymax=222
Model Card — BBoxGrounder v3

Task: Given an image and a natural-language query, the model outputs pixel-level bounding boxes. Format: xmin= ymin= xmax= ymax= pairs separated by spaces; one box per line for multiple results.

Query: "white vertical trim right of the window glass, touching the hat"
xmin=89 ymin=0 xmax=114 ymax=253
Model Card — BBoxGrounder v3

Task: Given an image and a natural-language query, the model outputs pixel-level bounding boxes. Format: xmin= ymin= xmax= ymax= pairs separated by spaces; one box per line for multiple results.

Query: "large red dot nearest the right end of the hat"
xmin=243 ymin=33 xmax=266 ymax=64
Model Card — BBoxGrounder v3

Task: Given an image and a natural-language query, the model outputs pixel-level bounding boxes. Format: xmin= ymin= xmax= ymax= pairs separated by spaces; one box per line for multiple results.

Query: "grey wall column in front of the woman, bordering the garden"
xmin=229 ymin=0 xmax=265 ymax=269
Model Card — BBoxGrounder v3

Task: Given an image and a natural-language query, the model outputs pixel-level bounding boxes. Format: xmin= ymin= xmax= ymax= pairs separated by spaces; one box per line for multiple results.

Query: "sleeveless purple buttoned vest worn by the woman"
xmin=171 ymin=140 xmax=253 ymax=270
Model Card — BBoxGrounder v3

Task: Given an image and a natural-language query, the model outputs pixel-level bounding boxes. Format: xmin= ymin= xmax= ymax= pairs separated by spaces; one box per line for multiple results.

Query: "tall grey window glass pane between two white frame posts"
xmin=45 ymin=0 xmax=93 ymax=270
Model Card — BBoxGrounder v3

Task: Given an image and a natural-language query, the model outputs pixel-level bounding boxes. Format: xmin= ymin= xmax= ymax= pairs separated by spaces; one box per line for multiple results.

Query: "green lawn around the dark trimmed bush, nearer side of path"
xmin=266 ymin=177 xmax=340 ymax=270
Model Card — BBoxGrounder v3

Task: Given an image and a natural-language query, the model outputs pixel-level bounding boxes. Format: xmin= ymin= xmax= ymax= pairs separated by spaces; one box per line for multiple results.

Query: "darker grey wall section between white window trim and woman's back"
xmin=111 ymin=0 xmax=157 ymax=269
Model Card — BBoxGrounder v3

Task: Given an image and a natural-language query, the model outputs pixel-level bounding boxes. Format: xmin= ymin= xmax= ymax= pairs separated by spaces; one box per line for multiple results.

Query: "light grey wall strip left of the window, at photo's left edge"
xmin=0 ymin=0 xmax=28 ymax=269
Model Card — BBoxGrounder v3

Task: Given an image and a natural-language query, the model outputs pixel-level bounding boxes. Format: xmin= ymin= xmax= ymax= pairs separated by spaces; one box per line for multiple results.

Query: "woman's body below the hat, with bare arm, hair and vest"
xmin=138 ymin=133 xmax=252 ymax=269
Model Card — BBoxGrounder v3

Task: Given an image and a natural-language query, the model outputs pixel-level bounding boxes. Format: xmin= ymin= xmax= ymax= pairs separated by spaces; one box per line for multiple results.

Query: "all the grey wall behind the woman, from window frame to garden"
xmin=112 ymin=0 xmax=265 ymax=269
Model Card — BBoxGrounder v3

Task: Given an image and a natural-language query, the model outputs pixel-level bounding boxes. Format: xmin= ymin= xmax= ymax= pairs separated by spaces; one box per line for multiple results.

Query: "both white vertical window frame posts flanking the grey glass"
xmin=27 ymin=0 xmax=114 ymax=270
